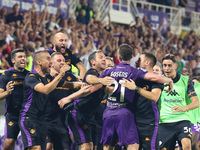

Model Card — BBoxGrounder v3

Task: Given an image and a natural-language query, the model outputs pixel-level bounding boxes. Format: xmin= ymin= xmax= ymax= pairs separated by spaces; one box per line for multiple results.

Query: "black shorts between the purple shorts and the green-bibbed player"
xmin=136 ymin=123 xmax=158 ymax=150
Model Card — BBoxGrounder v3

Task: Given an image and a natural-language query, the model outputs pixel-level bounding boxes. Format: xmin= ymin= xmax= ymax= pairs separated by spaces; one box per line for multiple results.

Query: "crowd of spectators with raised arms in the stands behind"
xmin=0 ymin=0 xmax=200 ymax=76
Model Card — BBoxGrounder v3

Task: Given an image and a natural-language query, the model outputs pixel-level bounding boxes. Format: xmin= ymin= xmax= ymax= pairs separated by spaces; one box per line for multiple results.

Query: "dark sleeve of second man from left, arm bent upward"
xmin=25 ymin=74 xmax=42 ymax=89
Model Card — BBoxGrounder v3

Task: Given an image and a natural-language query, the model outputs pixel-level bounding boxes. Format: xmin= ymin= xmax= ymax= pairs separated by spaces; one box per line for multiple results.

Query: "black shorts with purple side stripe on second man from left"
xmin=19 ymin=117 xmax=47 ymax=150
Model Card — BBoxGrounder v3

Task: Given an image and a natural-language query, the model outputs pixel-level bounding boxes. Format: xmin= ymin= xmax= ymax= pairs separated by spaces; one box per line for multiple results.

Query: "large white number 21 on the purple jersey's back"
xmin=108 ymin=80 xmax=125 ymax=102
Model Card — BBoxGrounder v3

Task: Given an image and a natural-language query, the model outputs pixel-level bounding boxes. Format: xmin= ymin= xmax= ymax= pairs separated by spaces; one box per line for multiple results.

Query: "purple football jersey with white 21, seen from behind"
xmin=100 ymin=63 xmax=147 ymax=118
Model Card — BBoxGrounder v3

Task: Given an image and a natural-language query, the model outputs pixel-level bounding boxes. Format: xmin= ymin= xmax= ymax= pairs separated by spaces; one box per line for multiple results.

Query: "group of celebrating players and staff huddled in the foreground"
xmin=0 ymin=33 xmax=200 ymax=150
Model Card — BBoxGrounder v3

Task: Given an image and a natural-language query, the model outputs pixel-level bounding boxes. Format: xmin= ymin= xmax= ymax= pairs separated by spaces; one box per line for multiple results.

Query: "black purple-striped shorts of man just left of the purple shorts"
xmin=68 ymin=109 xmax=97 ymax=145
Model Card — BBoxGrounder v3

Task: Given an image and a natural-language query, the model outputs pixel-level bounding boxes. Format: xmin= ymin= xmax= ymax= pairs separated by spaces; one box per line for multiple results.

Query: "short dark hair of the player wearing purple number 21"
xmin=119 ymin=44 xmax=133 ymax=61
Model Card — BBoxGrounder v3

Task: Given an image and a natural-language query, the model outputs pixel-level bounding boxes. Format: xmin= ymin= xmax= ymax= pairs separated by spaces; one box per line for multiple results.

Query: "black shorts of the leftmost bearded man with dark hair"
xmin=4 ymin=113 xmax=20 ymax=140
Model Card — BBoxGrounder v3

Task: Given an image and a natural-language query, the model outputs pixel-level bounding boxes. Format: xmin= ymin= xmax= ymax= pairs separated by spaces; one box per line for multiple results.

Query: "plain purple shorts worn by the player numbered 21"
xmin=101 ymin=115 xmax=139 ymax=146
